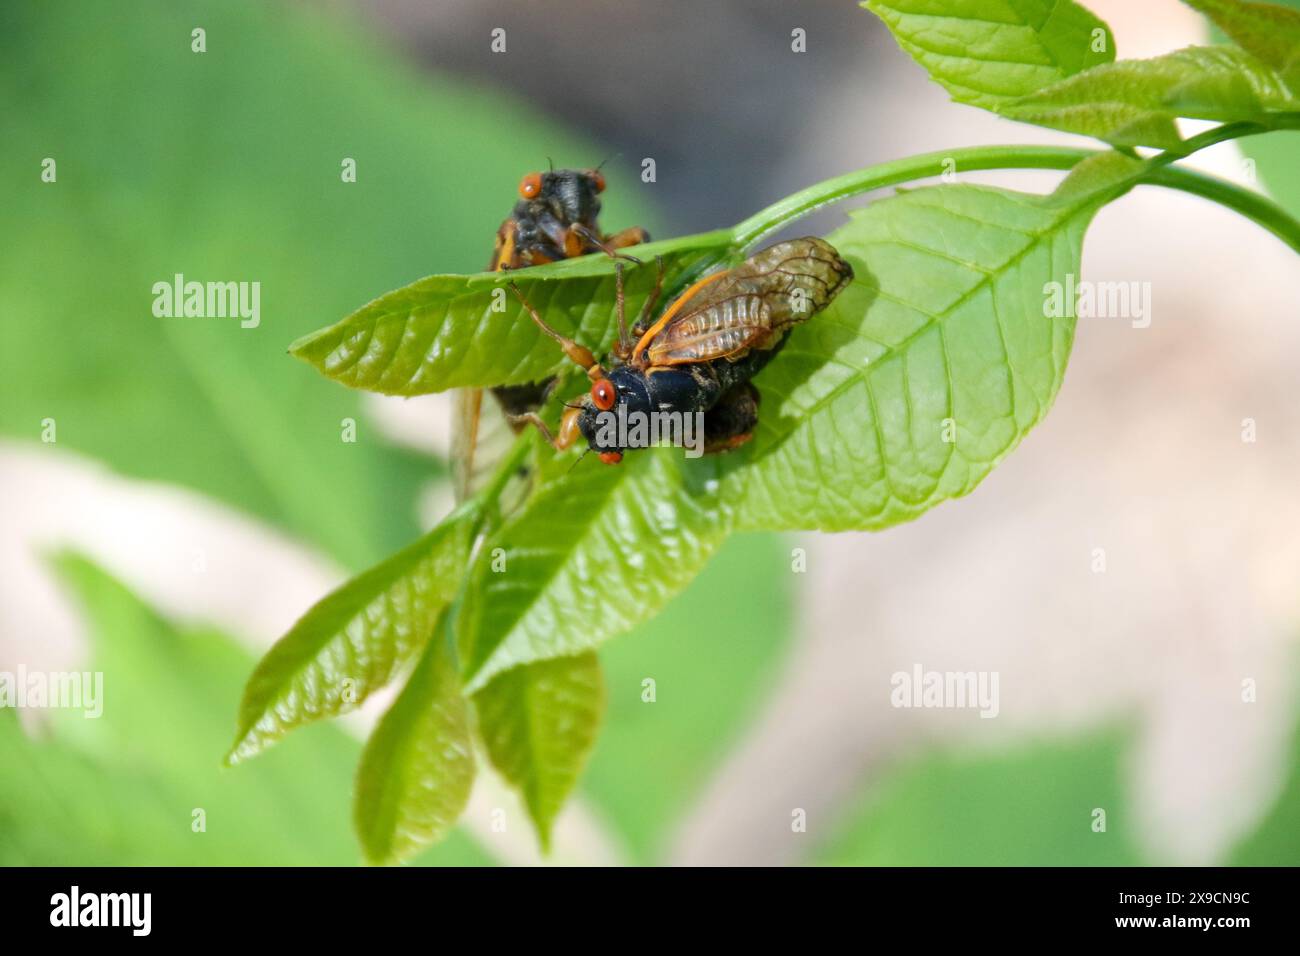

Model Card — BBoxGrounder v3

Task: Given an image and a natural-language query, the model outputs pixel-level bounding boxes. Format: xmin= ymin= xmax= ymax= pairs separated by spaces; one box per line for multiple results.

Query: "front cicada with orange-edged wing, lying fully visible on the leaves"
xmin=512 ymin=237 xmax=853 ymax=464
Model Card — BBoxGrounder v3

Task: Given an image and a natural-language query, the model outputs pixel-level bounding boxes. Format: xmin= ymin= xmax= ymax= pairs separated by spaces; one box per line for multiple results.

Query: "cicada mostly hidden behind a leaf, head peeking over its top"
xmin=454 ymin=169 xmax=650 ymax=499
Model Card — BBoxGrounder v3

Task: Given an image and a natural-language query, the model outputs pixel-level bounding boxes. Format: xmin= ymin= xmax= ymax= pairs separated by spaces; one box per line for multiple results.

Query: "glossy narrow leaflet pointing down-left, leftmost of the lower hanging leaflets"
xmin=226 ymin=507 xmax=477 ymax=763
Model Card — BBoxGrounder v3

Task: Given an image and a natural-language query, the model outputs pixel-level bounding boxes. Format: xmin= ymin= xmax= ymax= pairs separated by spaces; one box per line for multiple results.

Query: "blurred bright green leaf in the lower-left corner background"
xmin=0 ymin=554 xmax=490 ymax=866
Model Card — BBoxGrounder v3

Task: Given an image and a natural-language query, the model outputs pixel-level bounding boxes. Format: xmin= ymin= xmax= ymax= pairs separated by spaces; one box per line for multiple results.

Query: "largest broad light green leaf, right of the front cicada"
xmin=722 ymin=185 xmax=1100 ymax=531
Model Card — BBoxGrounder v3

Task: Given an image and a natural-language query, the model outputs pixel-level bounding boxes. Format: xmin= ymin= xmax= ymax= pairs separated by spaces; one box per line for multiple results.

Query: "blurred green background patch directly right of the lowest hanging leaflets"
xmin=582 ymin=533 xmax=794 ymax=864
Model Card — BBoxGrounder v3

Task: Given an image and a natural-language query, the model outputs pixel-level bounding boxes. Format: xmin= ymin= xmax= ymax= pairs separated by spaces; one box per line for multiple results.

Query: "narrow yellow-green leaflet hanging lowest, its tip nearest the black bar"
xmin=354 ymin=626 xmax=475 ymax=864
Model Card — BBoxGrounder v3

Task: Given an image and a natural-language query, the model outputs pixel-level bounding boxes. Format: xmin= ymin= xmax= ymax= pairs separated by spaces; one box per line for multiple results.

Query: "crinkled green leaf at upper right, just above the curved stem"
xmin=1002 ymin=47 xmax=1300 ymax=150
